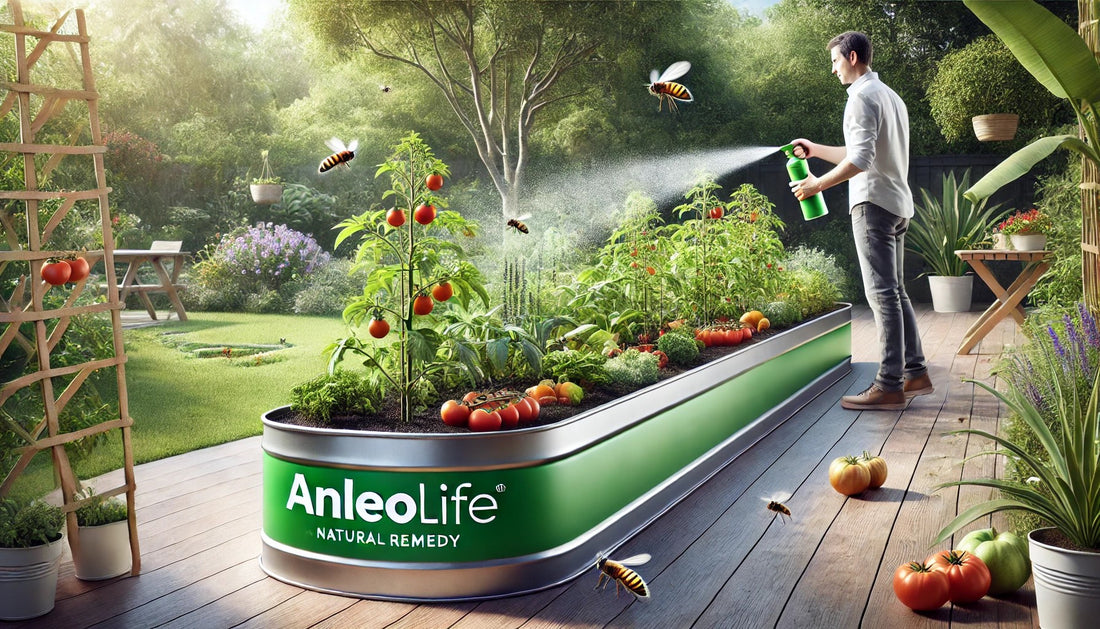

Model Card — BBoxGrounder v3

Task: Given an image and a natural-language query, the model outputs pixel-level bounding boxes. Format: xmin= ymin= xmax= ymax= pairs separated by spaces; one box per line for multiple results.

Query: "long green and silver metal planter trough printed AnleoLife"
xmin=261 ymin=306 xmax=851 ymax=600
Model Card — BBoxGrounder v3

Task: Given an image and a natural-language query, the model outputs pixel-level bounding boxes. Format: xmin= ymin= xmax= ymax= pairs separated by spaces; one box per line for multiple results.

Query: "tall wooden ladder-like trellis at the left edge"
xmin=0 ymin=0 xmax=141 ymax=574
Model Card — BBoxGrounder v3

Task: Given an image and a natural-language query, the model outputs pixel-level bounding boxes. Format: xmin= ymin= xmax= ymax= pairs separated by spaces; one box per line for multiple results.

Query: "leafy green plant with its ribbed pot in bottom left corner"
xmin=0 ymin=499 xmax=65 ymax=620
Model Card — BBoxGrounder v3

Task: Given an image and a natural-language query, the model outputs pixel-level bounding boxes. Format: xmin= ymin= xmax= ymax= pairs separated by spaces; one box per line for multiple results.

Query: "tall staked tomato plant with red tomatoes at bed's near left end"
xmin=329 ymin=133 xmax=490 ymax=421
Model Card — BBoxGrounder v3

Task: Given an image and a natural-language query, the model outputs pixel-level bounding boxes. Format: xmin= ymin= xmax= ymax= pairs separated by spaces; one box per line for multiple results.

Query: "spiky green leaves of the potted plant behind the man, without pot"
xmin=905 ymin=169 xmax=1008 ymax=276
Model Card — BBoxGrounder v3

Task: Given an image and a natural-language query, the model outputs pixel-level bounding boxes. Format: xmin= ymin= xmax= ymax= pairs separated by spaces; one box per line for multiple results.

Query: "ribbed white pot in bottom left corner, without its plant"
xmin=0 ymin=539 xmax=62 ymax=620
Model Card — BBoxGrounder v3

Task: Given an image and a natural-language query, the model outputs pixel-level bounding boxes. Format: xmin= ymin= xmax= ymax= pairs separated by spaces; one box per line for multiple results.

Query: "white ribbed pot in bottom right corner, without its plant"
xmin=1027 ymin=529 xmax=1100 ymax=629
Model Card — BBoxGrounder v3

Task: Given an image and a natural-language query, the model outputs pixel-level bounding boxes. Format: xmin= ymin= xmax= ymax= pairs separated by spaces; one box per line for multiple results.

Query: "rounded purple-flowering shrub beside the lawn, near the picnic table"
xmin=215 ymin=223 xmax=331 ymax=290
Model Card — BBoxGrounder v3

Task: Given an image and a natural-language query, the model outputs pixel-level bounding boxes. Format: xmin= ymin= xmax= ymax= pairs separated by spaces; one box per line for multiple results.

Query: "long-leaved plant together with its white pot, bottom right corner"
xmin=934 ymin=311 xmax=1100 ymax=629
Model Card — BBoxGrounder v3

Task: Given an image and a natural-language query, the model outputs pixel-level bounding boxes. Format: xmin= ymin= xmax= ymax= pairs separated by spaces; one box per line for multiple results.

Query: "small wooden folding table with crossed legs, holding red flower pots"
xmin=955 ymin=249 xmax=1051 ymax=354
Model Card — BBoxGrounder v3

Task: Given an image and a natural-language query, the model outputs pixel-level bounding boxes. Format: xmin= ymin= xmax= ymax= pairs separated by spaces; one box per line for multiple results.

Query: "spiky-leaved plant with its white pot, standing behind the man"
xmin=905 ymin=169 xmax=1003 ymax=312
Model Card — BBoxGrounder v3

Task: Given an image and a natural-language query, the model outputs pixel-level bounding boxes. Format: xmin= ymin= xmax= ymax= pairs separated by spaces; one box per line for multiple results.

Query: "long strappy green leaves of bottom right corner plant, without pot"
xmin=935 ymin=306 xmax=1100 ymax=550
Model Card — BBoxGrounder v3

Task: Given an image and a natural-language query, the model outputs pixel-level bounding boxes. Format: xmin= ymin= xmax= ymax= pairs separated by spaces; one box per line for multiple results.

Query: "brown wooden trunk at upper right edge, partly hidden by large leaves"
xmin=1077 ymin=0 xmax=1100 ymax=312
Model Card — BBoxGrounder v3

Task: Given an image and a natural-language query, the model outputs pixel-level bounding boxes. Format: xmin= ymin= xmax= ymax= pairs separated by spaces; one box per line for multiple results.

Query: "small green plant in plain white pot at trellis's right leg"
xmin=73 ymin=487 xmax=132 ymax=581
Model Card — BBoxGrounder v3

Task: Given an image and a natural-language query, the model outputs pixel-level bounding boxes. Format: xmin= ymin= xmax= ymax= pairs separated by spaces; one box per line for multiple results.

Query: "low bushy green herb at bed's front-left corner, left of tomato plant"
xmin=290 ymin=369 xmax=382 ymax=423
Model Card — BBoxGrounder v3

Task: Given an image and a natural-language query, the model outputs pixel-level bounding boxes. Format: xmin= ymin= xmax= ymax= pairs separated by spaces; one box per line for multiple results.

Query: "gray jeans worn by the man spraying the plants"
xmin=851 ymin=202 xmax=928 ymax=391
